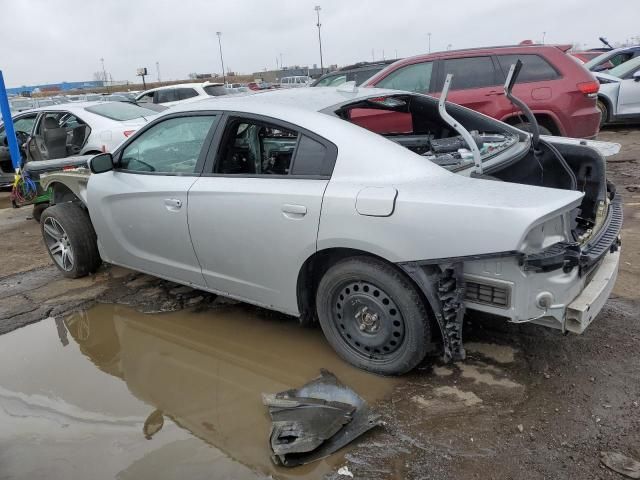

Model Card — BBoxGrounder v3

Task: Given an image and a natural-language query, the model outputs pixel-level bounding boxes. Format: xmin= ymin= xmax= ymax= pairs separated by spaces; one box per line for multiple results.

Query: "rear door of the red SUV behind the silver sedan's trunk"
xmin=436 ymin=55 xmax=513 ymax=119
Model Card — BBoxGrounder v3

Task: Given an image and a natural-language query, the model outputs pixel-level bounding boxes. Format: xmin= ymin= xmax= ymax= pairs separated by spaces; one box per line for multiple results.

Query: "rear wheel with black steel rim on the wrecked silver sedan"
xmin=316 ymin=256 xmax=431 ymax=375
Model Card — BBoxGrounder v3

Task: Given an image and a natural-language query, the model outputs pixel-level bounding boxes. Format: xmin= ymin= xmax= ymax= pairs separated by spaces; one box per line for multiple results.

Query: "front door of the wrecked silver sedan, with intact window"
xmin=87 ymin=112 xmax=219 ymax=287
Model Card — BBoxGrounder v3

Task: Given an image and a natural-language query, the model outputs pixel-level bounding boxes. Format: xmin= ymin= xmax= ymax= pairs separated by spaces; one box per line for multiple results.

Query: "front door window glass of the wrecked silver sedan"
xmin=119 ymin=115 xmax=218 ymax=174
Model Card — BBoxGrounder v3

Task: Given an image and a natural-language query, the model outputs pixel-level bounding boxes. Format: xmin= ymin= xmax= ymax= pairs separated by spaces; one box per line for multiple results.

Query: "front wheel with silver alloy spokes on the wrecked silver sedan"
xmin=40 ymin=202 xmax=102 ymax=278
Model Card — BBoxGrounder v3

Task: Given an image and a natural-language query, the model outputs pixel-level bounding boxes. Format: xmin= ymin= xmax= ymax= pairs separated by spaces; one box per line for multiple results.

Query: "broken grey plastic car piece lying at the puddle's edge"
xmin=262 ymin=369 xmax=382 ymax=467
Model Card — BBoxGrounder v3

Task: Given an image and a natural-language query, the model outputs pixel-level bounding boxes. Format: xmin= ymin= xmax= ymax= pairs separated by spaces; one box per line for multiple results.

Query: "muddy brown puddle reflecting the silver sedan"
xmin=0 ymin=305 xmax=395 ymax=479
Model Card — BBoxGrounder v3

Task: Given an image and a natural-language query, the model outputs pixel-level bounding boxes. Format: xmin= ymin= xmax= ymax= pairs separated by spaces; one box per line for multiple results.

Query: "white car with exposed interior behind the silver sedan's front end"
xmin=0 ymin=102 xmax=158 ymax=184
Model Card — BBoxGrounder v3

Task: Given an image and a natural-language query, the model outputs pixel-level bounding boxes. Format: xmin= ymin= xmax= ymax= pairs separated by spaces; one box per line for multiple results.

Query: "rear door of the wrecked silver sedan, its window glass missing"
xmin=189 ymin=115 xmax=337 ymax=314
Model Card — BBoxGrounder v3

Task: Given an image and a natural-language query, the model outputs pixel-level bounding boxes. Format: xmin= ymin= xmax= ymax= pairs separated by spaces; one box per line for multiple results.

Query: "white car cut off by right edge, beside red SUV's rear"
xmin=595 ymin=57 xmax=640 ymax=125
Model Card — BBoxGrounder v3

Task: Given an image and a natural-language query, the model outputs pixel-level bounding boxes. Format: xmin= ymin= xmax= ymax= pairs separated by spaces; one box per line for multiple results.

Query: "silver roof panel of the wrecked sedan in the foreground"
xmin=170 ymin=82 xmax=412 ymax=114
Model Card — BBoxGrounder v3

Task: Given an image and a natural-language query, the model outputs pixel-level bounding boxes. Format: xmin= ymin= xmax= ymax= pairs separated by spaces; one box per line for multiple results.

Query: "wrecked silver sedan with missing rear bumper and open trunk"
xmin=41 ymin=88 xmax=622 ymax=374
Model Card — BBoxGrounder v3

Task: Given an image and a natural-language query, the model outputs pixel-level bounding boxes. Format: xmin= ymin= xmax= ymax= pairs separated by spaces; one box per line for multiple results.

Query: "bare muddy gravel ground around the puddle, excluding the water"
xmin=0 ymin=128 xmax=640 ymax=479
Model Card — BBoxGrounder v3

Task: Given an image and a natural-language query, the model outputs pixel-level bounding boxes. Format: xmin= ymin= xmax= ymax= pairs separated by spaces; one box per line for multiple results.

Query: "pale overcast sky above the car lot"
xmin=0 ymin=0 xmax=640 ymax=87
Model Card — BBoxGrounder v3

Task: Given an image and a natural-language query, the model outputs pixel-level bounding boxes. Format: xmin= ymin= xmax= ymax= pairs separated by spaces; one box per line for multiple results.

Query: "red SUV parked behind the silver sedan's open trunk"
xmin=362 ymin=45 xmax=600 ymax=138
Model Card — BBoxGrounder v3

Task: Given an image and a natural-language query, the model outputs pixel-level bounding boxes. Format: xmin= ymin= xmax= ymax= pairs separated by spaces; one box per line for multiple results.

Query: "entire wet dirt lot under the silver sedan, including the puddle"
xmin=0 ymin=128 xmax=640 ymax=479
